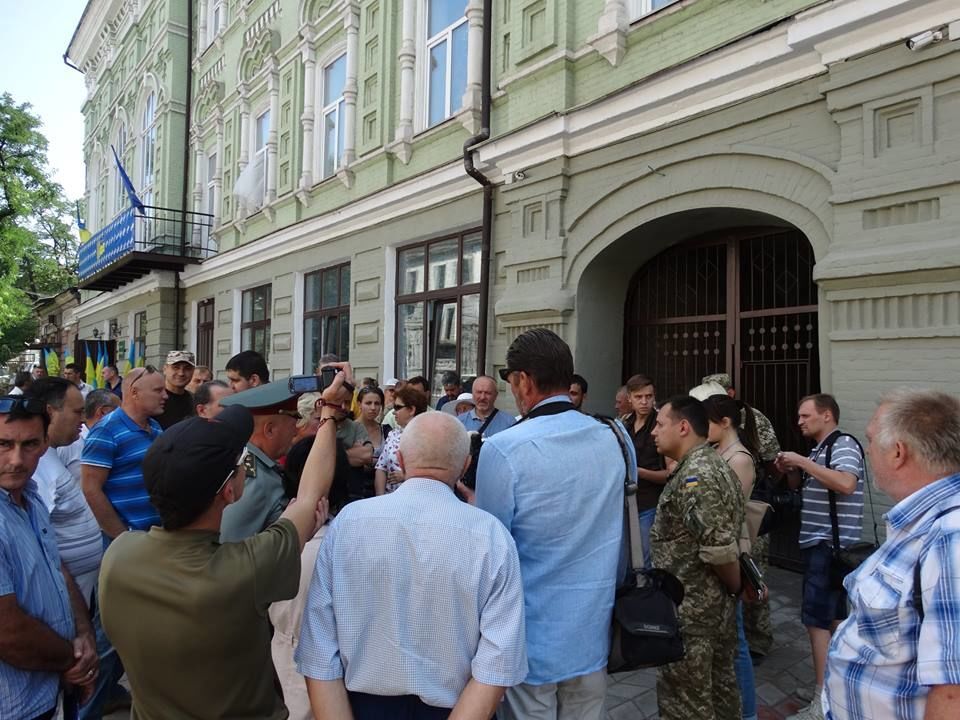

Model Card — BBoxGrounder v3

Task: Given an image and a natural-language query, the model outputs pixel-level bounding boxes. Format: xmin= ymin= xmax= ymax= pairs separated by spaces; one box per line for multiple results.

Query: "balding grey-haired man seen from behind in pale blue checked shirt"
xmin=296 ymin=412 xmax=527 ymax=720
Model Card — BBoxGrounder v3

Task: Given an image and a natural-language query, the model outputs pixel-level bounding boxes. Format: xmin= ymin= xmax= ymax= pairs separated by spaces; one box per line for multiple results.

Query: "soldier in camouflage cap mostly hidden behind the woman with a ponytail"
xmin=703 ymin=373 xmax=780 ymax=657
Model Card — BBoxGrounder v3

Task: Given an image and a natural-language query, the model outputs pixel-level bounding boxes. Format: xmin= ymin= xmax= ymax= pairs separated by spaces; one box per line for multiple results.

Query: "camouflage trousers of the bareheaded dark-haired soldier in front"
xmin=657 ymin=626 xmax=741 ymax=720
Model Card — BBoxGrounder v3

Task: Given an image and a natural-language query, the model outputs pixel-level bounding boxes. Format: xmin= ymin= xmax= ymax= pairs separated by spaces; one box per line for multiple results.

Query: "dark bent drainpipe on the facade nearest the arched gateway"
xmin=463 ymin=0 xmax=493 ymax=372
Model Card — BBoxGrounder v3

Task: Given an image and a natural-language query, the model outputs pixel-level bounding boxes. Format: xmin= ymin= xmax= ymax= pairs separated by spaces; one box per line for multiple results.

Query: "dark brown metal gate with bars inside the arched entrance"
xmin=623 ymin=228 xmax=820 ymax=565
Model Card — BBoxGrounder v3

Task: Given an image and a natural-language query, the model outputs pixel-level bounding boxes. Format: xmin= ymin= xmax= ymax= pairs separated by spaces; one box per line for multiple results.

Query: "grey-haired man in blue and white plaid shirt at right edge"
xmin=823 ymin=389 xmax=960 ymax=720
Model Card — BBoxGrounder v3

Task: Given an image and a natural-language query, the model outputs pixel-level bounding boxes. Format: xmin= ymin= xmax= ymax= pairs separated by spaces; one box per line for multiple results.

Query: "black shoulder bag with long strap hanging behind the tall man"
xmin=597 ymin=417 xmax=684 ymax=673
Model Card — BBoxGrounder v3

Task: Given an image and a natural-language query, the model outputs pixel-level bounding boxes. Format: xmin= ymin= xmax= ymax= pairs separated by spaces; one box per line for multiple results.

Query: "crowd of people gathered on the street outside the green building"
xmin=0 ymin=328 xmax=960 ymax=720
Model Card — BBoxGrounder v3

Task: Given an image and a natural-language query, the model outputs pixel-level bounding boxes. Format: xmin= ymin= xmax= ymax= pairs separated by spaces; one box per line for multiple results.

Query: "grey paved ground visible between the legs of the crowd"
xmin=104 ymin=567 xmax=813 ymax=720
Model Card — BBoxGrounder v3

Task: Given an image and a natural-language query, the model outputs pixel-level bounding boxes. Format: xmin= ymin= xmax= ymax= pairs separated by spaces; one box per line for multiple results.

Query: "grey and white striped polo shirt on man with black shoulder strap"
xmin=800 ymin=435 xmax=866 ymax=548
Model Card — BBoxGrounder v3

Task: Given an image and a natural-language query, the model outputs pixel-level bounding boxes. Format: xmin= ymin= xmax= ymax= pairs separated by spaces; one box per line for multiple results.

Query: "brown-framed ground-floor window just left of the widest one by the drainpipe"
xmin=303 ymin=263 xmax=350 ymax=372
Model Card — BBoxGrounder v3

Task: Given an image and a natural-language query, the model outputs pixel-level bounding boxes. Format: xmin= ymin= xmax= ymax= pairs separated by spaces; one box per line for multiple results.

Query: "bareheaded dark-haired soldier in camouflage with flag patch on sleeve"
xmin=651 ymin=396 xmax=744 ymax=720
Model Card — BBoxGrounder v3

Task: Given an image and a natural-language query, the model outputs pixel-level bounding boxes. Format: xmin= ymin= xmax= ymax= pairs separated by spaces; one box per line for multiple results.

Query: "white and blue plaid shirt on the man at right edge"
xmin=823 ymin=474 xmax=960 ymax=720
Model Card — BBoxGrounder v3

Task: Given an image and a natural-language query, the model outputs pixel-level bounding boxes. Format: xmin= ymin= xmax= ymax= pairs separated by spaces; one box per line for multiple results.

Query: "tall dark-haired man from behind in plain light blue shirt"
xmin=476 ymin=328 xmax=636 ymax=720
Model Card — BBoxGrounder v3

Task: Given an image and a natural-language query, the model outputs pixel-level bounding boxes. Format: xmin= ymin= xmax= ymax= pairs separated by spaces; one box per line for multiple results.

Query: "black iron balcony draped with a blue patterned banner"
xmin=79 ymin=205 xmax=217 ymax=290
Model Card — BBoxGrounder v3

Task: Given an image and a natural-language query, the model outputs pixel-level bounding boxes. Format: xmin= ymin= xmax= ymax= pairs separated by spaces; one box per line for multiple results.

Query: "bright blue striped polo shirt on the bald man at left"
xmin=80 ymin=408 xmax=163 ymax=530
